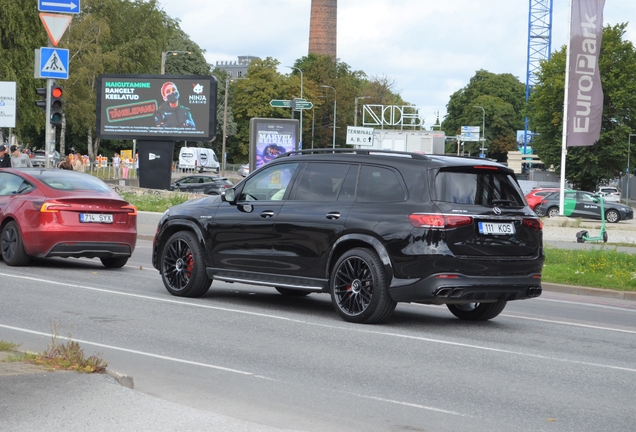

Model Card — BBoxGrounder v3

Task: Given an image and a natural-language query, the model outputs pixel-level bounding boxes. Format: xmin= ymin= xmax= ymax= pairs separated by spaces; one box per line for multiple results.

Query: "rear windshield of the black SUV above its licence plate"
xmin=435 ymin=170 xmax=525 ymax=207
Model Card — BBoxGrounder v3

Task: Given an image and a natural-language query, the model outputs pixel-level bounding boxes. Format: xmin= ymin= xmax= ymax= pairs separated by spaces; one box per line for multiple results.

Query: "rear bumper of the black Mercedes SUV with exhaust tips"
xmin=389 ymin=273 xmax=542 ymax=304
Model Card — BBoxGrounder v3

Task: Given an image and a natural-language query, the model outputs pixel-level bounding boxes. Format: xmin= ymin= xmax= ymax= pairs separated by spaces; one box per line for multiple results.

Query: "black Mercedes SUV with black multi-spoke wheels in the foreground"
xmin=152 ymin=149 xmax=544 ymax=323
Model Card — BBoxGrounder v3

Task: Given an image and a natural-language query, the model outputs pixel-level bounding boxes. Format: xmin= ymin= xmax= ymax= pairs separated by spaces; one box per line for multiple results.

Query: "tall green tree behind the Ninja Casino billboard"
xmin=63 ymin=0 xmax=210 ymax=160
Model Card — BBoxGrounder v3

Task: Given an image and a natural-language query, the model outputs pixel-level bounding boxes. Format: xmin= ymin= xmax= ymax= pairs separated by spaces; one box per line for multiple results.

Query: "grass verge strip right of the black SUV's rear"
xmin=542 ymin=247 xmax=636 ymax=291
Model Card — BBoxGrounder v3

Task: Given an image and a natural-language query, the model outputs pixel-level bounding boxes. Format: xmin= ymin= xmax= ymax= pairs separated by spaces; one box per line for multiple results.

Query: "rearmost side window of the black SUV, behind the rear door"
xmin=356 ymin=165 xmax=404 ymax=202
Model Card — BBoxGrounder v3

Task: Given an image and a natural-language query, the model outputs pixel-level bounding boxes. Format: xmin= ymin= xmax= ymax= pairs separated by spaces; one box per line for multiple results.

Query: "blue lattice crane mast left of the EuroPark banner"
xmin=523 ymin=0 xmax=553 ymax=154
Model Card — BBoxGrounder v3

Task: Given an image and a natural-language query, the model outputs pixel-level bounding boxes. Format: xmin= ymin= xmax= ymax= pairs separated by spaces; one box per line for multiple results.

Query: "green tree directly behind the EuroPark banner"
xmin=528 ymin=24 xmax=636 ymax=190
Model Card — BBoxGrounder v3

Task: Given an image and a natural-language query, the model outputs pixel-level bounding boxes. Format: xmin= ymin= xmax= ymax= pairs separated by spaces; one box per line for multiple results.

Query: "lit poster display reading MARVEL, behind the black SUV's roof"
xmin=250 ymin=118 xmax=298 ymax=170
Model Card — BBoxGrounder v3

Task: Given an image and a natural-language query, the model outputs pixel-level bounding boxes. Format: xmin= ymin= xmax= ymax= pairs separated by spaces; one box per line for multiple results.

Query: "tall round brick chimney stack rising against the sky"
xmin=309 ymin=0 xmax=338 ymax=60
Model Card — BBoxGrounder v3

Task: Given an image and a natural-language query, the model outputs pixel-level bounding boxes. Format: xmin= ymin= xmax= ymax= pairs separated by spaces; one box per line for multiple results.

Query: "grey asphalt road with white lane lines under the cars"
xmin=0 ymin=230 xmax=636 ymax=431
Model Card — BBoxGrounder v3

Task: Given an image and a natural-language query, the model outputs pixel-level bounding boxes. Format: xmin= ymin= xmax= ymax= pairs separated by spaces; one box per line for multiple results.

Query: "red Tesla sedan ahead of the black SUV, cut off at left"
xmin=0 ymin=168 xmax=137 ymax=268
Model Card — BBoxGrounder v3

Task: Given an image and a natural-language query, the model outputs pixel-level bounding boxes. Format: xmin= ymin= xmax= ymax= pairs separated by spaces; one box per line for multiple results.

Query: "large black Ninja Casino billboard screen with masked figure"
xmin=97 ymin=75 xmax=217 ymax=141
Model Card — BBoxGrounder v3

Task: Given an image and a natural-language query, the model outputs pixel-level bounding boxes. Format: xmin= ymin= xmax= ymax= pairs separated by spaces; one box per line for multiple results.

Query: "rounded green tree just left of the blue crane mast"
xmin=442 ymin=70 xmax=525 ymax=161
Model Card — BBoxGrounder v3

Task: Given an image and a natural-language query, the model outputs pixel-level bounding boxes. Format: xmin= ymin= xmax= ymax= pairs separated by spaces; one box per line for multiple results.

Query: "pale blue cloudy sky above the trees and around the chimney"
xmin=159 ymin=0 xmax=636 ymax=126
